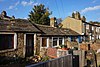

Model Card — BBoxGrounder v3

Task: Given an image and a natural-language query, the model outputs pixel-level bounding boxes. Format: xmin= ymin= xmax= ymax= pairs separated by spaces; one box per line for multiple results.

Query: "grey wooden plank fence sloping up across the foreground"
xmin=26 ymin=55 xmax=72 ymax=67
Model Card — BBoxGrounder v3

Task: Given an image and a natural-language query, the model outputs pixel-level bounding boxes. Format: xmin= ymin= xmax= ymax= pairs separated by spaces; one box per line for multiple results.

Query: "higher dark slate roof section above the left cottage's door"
xmin=0 ymin=19 xmax=40 ymax=32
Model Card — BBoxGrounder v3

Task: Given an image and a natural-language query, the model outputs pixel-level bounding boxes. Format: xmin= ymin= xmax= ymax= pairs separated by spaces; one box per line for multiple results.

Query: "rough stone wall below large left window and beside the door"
xmin=0 ymin=33 xmax=24 ymax=57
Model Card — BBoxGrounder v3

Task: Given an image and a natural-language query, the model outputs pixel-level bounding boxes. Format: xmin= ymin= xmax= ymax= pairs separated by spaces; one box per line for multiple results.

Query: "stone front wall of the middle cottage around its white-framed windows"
xmin=37 ymin=37 xmax=78 ymax=56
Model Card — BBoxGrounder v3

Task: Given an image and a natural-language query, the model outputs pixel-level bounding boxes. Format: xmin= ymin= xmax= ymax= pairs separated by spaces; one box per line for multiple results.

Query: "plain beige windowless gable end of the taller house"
xmin=61 ymin=17 xmax=84 ymax=34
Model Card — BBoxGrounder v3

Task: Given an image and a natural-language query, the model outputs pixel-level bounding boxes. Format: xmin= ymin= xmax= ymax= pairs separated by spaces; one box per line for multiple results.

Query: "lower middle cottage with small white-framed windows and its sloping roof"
xmin=35 ymin=24 xmax=80 ymax=55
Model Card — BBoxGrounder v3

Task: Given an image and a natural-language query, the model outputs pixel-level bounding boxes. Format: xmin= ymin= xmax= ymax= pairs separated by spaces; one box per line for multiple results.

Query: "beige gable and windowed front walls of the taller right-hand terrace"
xmin=61 ymin=17 xmax=100 ymax=41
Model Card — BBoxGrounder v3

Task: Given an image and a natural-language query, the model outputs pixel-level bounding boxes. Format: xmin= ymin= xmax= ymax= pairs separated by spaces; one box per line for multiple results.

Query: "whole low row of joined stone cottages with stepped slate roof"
xmin=0 ymin=13 xmax=80 ymax=58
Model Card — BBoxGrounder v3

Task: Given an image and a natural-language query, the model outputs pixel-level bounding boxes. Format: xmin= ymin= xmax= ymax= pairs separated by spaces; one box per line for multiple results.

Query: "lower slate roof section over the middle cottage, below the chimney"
xmin=36 ymin=24 xmax=80 ymax=36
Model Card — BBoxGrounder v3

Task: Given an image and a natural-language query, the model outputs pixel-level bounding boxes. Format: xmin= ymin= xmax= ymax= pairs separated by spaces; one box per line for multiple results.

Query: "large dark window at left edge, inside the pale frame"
xmin=0 ymin=34 xmax=14 ymax=50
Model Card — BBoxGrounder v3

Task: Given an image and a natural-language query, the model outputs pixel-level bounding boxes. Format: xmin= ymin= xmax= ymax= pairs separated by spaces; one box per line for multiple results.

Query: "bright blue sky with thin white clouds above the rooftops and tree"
xmin=0 ymin=0 xmax=100 ymax=22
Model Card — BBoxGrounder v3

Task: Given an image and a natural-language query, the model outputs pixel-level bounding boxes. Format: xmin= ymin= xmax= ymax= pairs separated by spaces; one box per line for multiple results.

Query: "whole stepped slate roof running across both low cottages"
xmin=0 ymin=19 xmax=80 ymax=36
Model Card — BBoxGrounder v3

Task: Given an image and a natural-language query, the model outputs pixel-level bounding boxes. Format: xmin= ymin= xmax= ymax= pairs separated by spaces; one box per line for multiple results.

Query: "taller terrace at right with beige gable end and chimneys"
xmin=61 ymin=12 xmax=100 ymax=42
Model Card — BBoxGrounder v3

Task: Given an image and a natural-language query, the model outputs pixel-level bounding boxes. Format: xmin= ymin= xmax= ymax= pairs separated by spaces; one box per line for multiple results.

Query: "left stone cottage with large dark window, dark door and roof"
xmin=0 ymin=19 xmax=40 ymax=57
